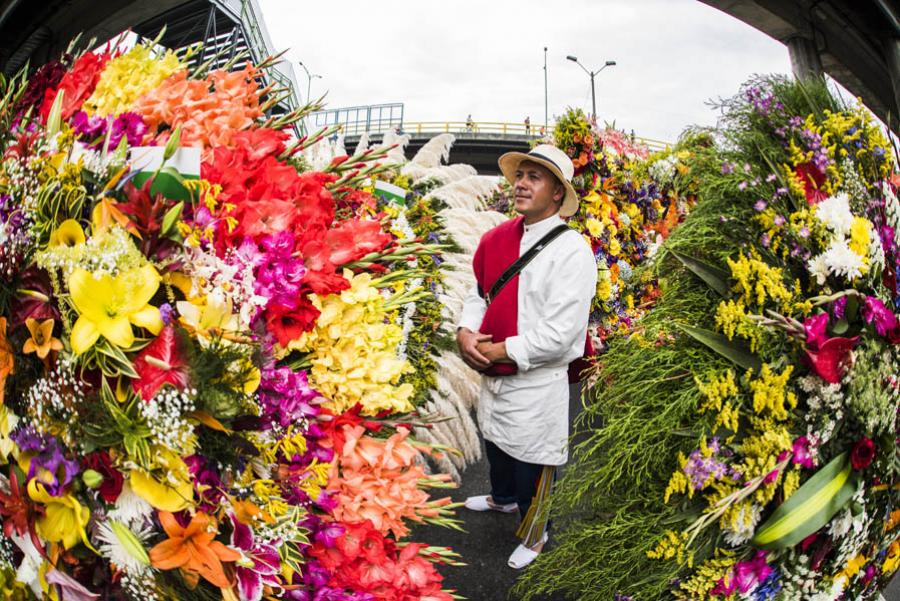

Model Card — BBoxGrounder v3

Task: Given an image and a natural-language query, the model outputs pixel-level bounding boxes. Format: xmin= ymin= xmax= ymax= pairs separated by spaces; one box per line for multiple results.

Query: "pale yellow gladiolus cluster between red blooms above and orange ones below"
xmin=289 ymin=271 xmax=413 ymax=415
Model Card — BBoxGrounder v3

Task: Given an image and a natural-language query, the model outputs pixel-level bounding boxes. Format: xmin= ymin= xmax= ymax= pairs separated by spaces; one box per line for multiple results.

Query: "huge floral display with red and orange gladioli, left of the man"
xmin=0 ymin=39 xmax=455 ymax=601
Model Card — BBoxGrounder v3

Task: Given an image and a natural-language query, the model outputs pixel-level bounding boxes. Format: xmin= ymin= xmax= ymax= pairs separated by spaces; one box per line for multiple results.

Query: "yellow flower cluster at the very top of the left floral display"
xmin=84 ymin=44 xmax=182 ymax=117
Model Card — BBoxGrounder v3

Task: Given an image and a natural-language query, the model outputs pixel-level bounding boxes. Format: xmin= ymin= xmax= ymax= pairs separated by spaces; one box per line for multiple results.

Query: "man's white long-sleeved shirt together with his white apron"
xmin=458 ymin=215 xmax=597 ymax=465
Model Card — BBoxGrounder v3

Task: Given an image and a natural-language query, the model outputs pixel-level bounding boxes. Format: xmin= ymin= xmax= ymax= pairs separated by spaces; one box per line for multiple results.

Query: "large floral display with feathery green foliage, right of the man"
xmin=522 ymin=78 xmax=900 ymax=601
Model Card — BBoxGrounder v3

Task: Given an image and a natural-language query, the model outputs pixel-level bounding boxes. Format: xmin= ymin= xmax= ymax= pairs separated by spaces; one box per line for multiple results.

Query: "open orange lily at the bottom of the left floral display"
xmin=150 ymin=511 xmax=241 ymax=588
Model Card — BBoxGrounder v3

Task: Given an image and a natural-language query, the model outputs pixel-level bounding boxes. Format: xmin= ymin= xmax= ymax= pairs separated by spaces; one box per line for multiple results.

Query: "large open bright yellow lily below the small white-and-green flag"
xmin=69 ymin=265 xmax=163 ymax=355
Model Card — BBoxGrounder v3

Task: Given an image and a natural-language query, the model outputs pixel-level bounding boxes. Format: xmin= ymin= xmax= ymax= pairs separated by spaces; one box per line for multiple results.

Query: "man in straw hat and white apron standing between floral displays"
xmin=457 ymin=144 xmax=597 ymax=569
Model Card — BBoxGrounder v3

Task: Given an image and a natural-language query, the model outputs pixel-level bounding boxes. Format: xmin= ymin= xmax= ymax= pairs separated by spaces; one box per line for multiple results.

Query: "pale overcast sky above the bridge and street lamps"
xmin=258 ymin=0 xmax=790 ymax=141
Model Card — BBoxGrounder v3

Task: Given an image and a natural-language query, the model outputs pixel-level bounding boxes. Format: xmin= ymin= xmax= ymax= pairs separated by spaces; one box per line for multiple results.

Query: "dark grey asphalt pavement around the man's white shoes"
xmin=409 ymin=390 xmax=900 ymax=601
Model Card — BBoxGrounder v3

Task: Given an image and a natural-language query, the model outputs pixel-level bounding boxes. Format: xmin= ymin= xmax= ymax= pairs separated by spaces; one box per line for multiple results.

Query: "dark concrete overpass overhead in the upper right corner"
xmin=701 ymin=0 xmax=900 ymax=127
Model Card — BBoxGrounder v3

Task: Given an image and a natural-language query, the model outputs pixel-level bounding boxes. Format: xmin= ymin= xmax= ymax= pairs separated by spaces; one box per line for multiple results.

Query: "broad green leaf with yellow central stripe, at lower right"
xmin=751 ymin=452 xmax=859 ymax=550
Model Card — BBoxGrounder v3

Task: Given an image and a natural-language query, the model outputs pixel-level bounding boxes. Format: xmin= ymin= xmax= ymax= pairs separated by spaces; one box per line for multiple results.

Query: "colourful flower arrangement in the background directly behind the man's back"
xmin=553 ymin=109 xmax=694 ymax=349
